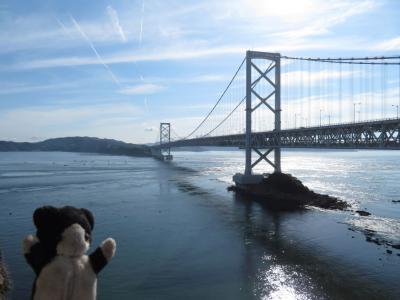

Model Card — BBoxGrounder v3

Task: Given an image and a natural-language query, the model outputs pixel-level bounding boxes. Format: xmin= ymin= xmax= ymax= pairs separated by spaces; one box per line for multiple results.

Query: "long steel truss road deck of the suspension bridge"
xmin=153 ymin=119 xmax=400 ymax=150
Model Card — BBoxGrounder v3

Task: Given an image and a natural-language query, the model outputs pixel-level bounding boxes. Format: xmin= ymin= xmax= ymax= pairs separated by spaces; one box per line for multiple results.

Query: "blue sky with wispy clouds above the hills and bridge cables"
xmin=0 ymin=0 xmax=400 ymax=143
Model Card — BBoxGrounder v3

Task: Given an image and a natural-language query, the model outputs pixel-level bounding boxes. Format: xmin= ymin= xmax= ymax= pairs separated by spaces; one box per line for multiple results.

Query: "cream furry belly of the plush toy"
xmin=34 ymin=255 xmax=97 ymax=300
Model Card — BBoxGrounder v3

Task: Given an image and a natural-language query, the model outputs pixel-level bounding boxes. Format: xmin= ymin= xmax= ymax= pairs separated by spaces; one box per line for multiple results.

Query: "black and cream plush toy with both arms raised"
xmin=23 ymin=206 xmax=116 ymax=300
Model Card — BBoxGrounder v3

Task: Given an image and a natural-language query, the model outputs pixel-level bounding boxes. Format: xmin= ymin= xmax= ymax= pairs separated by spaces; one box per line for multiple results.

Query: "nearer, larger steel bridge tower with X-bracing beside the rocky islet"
xmin=233 ymin=51 xmax=281 ymax=184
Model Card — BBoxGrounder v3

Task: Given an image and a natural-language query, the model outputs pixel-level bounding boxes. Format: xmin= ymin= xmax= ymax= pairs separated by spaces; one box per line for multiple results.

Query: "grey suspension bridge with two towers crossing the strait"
xmin=152 ymin=51 xmax=400 ymax=184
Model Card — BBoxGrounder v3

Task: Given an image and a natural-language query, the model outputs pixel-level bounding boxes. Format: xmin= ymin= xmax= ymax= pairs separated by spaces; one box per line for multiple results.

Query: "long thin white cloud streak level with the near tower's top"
xmin=5 ymin=38 xmax=398 ymax=72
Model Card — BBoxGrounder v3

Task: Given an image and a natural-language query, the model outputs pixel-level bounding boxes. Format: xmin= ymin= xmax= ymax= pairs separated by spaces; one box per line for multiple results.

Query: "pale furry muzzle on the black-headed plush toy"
xmin=57 ymin=224 xmax=90 ymax=257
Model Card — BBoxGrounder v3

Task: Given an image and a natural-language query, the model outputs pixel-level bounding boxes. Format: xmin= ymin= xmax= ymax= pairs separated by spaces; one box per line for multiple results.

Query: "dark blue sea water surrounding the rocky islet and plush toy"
xmin=0 ymin=149 xmax=400 ymax=300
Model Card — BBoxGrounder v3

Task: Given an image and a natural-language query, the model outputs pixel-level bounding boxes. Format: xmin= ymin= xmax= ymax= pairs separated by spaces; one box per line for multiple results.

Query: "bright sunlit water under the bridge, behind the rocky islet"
xmin=177 ymin=150 xmax=400 ymax=244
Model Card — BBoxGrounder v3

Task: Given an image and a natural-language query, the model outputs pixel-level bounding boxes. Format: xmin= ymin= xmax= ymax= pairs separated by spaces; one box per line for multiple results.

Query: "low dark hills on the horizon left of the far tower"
xmin=0 ymin=137 xmax=150 ymax=156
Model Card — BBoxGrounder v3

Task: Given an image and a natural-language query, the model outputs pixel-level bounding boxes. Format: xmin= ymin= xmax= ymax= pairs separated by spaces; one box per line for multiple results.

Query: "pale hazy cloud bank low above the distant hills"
xmin=0 ymin=102 xmax=143 ymax=141
